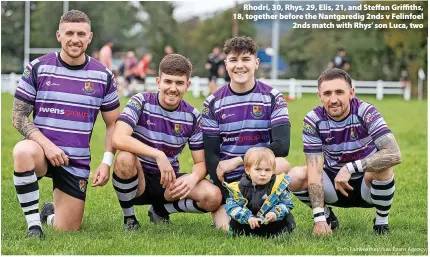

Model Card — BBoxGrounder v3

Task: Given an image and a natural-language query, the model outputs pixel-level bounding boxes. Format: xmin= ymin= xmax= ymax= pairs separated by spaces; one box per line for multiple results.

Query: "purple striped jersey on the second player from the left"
xmin=118 ymin=92 xmax=203 ymax=173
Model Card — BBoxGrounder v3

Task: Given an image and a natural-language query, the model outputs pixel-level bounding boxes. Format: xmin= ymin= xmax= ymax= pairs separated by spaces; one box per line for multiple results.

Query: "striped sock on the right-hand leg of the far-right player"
xmin=370 ymin=175 xmax=396 ymax=225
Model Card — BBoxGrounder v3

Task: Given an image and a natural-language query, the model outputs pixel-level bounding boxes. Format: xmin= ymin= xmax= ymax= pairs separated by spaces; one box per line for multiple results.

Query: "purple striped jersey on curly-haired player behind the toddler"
xmin=202 ymin=80 xmax=290 ymax=182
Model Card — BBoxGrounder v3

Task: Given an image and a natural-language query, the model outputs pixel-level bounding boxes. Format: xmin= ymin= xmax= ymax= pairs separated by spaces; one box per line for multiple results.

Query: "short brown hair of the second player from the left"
xmin=158 ymin=54 xmax=193 ymax=78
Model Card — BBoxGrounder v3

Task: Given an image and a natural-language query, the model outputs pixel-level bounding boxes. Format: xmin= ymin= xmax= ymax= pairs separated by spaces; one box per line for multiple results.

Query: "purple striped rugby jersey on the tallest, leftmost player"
xmin=15 ymin=52 xmax=119 ymax=178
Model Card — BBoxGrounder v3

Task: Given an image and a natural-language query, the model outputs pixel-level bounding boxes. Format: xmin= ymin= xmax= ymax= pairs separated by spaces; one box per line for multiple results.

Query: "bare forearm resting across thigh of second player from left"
xmin=112 ymin=133 xmax=163 ymax=159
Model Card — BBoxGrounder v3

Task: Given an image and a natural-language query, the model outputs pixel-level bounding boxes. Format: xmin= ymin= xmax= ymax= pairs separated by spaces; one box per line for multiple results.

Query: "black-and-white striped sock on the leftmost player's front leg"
xmin=13 ymin=170 xmax=42 ymax=229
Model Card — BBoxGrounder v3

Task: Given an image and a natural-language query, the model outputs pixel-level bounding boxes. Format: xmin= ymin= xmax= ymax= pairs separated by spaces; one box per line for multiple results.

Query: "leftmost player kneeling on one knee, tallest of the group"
xmin=12 ymin=10 xmax=120 ymax=239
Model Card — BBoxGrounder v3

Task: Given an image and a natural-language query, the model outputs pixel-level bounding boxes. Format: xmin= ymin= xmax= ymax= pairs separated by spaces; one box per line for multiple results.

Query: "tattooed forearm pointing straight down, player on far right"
xmin=306 ymin=154 xmax=324 ymax=208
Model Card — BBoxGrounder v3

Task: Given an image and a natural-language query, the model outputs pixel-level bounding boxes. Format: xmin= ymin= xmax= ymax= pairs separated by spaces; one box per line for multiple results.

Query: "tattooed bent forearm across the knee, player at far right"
xmin=361 ymin=133 xmax=402 ymax=172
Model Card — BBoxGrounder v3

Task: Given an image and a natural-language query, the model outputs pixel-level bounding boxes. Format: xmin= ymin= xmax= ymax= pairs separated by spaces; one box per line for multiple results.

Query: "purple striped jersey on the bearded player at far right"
xmin=303 ymin=98 xmax=391 ymax=179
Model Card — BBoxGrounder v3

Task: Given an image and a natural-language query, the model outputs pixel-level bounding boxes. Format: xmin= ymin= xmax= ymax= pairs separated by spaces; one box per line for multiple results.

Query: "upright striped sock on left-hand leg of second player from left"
xmin=112 ymin=172 xmax=137 ymax=222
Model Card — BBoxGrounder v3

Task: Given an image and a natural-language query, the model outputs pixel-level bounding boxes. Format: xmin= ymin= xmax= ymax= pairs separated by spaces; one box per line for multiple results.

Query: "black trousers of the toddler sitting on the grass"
xmin=230 ymin=214 xmax=288 ymax=237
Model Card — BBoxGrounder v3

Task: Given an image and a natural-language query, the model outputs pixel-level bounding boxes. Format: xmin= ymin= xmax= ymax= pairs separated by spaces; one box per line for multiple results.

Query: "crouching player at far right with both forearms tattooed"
xmin=288 ymin=68 xmax=401 ymax=234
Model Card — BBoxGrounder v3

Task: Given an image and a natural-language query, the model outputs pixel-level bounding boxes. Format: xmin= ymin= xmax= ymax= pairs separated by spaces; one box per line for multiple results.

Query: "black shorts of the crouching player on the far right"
xmin=323 ymin=172 xmax=374 ymax=208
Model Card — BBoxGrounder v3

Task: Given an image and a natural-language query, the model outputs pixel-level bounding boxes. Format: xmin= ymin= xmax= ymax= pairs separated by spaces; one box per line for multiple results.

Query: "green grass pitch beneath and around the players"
xmin=1 ymin=94 xmax=427 ymax=255
